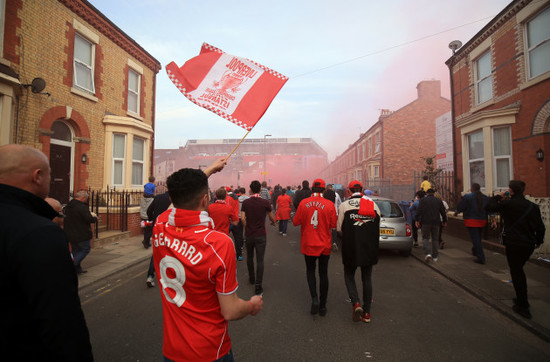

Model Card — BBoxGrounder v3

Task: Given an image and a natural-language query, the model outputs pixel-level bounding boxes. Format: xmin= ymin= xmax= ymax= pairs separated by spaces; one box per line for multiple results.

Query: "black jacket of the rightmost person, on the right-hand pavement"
xmin=486 ymin=195 xmax=546 ymax=245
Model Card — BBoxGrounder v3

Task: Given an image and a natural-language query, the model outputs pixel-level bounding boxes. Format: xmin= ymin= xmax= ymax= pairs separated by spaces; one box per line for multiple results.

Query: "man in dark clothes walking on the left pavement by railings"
xmin=63 ymin=190 xmax=97 ymax=274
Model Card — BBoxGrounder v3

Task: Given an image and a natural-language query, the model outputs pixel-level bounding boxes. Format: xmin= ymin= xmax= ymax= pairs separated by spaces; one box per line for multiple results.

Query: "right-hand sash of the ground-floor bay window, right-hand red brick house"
xmin=493 ymin=127 xmax=512 ymax=188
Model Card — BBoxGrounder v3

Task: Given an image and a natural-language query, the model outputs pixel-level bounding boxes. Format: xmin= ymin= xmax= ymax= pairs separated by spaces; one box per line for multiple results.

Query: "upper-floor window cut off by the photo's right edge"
xmin=527 ymin=8 xmax=550 ymax=79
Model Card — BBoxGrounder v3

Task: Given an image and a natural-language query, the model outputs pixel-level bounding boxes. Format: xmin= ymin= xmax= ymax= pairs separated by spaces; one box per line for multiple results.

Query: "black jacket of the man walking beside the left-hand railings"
xmin=63 ymin=199 xmax=96 ymax=244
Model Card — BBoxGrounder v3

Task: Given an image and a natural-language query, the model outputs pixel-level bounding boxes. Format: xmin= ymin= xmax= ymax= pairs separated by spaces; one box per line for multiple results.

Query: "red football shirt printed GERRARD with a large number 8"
xmin=153 ymin=208 xmax=238 ymax=361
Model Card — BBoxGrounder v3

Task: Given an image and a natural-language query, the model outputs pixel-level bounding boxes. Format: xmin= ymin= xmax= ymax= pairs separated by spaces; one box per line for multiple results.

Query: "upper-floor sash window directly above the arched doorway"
xmin=73 ymin=33 xmax=95 ymax=93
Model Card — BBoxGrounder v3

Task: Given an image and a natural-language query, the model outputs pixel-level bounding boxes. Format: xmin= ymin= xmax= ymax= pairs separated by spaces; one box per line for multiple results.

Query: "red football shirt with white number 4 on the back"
xmin=292 ymin=193 xmax=337 ymax=256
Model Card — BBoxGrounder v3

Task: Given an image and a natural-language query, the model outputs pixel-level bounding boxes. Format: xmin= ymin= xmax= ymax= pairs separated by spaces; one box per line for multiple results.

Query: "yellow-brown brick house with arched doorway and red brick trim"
xmin=0 ymin=0 xmax=161 ymax=203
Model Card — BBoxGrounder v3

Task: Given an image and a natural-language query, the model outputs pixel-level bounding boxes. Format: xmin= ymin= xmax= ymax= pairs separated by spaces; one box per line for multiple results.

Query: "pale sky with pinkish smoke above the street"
xmin=89 ymin=0 xmax=510 ymax=161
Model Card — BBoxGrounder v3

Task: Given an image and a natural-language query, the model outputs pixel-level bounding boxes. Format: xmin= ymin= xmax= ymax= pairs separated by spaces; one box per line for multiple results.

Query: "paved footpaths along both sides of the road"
xmin=78 ymin=231 xmax=550 ymax=343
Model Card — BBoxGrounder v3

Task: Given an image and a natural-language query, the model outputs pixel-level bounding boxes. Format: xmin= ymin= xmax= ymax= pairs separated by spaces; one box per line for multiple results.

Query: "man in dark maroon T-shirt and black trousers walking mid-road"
xmin=241 ymin=180 xmax=275 ymax=295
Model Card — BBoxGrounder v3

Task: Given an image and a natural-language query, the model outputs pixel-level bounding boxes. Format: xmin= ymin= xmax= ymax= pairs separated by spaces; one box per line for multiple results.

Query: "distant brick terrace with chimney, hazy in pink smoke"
xmin=324 ymin=80 xmax=451 ymax=200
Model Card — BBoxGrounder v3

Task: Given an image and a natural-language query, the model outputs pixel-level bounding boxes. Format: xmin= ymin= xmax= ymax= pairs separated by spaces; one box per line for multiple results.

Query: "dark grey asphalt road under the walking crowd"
xmin=81 ymin=222 xmax=550 ymax=362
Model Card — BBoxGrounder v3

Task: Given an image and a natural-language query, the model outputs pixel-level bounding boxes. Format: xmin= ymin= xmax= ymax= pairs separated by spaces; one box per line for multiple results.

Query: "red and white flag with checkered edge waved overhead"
xmin=166 ymin=43 xmax=288 ymax=131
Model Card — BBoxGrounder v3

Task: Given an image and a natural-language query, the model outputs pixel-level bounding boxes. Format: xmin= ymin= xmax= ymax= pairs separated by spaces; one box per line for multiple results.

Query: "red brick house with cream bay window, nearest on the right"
xmin=446 ymin=0 xmax=550 ymax=246
